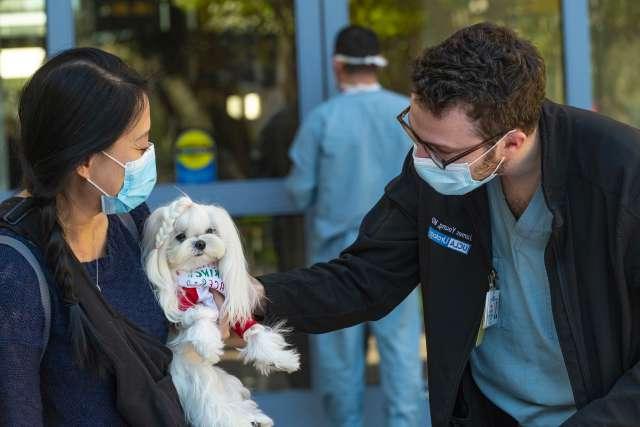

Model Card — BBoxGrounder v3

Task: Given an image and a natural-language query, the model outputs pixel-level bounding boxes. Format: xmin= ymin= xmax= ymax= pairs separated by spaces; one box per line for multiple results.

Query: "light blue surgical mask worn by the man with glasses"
xmin=413 ymin=144 xmax=504 ymax=196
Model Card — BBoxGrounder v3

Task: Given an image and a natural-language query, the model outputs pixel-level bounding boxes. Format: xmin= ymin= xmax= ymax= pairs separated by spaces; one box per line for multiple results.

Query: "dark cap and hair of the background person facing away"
xmin=333 ymin=25 xmax=380 ymax=73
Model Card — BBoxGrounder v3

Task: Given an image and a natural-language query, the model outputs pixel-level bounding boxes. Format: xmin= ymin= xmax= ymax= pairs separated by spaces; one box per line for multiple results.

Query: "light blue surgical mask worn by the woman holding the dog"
xmin=87 ymin=144 xmax=157 ymax=215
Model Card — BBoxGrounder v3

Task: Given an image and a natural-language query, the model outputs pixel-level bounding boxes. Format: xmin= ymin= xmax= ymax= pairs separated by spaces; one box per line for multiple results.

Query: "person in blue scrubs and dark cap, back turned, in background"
xmin=287 ymin=26 xmax=427 ymax=427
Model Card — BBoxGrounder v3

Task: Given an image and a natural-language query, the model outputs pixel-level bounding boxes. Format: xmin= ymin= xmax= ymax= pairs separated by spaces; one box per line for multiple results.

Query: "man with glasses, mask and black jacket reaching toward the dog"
xmin=250 ymin=23 xmax=640 ymax=426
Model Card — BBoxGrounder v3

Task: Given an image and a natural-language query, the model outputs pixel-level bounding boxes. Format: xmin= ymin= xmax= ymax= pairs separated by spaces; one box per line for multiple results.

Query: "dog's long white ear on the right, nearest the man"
xmin=209 ymin=206 xmax=258 ymax=325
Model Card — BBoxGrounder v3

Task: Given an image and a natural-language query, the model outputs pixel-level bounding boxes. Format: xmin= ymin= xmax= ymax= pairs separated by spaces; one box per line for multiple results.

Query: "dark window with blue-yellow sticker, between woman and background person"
xmin=75 ymin=0 xmax=298 ymax=182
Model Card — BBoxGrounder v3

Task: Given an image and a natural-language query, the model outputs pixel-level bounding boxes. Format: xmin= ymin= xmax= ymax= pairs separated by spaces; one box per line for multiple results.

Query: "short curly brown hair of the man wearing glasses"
xmin=412 ymin=23 xmax=545 ymax=138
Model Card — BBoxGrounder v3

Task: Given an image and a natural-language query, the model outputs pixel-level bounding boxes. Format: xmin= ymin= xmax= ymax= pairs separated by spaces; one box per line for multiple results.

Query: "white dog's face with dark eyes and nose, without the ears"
xmin=165 ymin=203 xmax=225 ymax=271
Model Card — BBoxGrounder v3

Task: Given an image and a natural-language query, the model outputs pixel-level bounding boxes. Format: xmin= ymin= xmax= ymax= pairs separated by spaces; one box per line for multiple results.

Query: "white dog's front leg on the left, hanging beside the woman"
xmin=180 ymin=305 xmax=224 ymax=364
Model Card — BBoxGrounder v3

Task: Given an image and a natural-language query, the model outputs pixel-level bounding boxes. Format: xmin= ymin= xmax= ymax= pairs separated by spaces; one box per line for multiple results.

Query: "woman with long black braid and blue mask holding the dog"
xmin=0 ymin=48 xmax=184 ymax=426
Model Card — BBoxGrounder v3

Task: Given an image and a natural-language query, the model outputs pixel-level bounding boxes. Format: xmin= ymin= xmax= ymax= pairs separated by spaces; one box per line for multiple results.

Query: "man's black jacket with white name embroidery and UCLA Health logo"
xmin=260 ymin=101 xmax=640 ymax=427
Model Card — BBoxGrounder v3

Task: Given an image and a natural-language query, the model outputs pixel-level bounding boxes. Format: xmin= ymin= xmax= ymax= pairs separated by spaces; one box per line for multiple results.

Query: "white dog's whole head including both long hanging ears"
xmin=142 ymin=197 xmax=258 ymax=324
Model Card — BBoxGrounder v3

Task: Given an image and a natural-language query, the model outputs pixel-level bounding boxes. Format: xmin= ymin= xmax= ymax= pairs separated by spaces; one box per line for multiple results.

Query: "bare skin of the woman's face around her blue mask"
xmin=88 ymin=97 xmax=151 ymax=204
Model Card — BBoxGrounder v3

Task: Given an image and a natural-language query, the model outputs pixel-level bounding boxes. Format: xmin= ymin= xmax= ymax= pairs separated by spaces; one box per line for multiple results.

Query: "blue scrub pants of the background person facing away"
xmin=311 ymin=289 xmax=427 ymax=427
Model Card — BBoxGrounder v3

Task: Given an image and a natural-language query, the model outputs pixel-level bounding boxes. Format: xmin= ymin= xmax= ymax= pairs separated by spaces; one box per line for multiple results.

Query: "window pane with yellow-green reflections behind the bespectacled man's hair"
xmin=350 ymin=0 xmax=564 ymax=102
